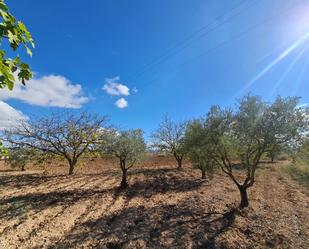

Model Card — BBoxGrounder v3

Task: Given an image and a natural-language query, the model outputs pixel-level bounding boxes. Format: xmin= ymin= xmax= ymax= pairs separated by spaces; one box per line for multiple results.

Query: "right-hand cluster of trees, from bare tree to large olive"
xmin=153 ymin=95 xmax=309 ymax=208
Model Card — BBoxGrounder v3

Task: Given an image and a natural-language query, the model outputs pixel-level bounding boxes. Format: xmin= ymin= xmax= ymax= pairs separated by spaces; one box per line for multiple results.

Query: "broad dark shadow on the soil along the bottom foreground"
xmin=48 ymin=199 xmax=236 ymax=249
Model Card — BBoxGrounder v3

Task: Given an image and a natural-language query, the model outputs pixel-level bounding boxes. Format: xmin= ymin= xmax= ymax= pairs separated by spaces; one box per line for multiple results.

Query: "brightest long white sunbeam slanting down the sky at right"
xmin=238 ymin=32 xmax=309 ymax=95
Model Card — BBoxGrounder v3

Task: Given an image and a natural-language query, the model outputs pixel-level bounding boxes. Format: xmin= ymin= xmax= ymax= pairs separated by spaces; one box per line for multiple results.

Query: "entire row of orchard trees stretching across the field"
xmin=1 ymin=95 xmax=309 ymax=208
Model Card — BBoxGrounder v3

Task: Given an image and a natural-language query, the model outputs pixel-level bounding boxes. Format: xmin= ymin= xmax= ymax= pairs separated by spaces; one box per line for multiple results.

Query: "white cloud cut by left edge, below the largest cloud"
xmin=0 ymin=100 xmax=28 ymax=130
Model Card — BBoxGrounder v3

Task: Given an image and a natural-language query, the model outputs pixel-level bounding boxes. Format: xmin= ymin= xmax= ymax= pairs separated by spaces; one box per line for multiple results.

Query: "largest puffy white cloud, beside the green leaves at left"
xmin=0 ymin=75 xmax=89 ymax=108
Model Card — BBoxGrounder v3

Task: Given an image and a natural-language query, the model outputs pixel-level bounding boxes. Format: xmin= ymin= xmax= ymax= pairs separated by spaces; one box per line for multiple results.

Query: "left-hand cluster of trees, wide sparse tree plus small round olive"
xmin=4 ymin=112 xmax=146 ymax=188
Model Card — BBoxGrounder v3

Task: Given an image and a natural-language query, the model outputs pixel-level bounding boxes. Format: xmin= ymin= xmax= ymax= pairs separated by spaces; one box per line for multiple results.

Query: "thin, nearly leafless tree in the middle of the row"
xmin=151 ymin=116 xmax=187 ymax=168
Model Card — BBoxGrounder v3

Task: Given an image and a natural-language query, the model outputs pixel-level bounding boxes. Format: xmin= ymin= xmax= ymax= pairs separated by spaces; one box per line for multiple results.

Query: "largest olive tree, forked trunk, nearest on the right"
xmin=192 ymin=95 xmax=309 ymax=208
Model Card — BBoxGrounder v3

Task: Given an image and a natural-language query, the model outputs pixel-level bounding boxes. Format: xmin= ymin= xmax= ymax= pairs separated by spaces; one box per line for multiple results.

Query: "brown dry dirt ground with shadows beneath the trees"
xmin=0 ymin=157 xmax=309 ymax=249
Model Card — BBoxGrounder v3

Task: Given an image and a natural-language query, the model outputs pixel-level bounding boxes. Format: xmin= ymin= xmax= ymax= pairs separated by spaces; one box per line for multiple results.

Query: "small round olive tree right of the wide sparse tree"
xmin=101 ymin=129 xmax=146 ymax=189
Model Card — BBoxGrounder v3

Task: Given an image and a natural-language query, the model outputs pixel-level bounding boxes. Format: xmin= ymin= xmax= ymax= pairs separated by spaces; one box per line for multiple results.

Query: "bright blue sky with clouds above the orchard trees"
xmin=0 ymin=0 xmax=309 ymax=136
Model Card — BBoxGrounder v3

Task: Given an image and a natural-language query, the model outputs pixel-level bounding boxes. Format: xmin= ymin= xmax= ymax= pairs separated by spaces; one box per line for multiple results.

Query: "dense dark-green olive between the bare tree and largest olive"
xmin=184 ymin=119 xmax=217 ymax=179
